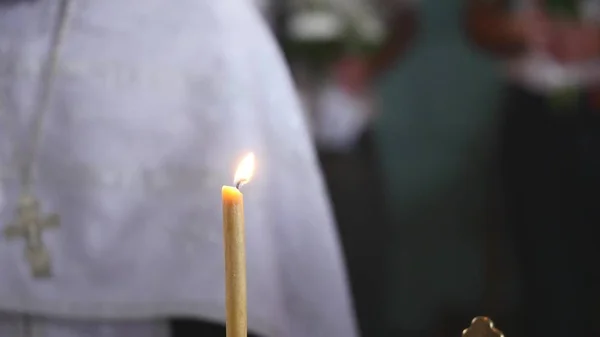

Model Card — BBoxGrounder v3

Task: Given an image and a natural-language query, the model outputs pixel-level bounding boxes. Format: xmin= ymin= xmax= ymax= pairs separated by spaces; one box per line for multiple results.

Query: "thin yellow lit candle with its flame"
xmin=222 ymin=153 xmax=254 ymax=337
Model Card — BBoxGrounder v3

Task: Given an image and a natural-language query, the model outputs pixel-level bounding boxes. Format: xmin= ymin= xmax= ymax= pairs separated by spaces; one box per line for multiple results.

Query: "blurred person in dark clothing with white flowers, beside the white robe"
xmin=275 ymin=0 xmax=417 ymax=336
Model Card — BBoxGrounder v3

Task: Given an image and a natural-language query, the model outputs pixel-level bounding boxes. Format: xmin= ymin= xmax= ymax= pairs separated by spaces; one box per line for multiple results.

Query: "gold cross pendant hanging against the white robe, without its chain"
xmin=4 ymin=195 xmax=60 ymax=278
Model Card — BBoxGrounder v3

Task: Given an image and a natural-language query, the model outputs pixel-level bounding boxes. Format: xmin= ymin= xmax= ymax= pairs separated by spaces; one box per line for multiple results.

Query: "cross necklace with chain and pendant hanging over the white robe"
xmin=4 ymin=0 xmax=73 ymax=278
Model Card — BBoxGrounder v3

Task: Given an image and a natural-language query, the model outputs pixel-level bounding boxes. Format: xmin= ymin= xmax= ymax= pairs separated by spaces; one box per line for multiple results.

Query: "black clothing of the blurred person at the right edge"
xmin=501 ymin=87 xmax=600 ymax=337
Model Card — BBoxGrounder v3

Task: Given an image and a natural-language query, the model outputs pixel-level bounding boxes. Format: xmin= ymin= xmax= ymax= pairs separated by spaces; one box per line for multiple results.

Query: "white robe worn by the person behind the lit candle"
xmin=0 ymin=0 xmax=356 ymax=337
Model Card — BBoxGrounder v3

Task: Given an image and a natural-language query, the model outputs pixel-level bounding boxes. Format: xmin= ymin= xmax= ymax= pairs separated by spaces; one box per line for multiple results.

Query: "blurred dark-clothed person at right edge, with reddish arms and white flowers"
xmin=466 ymin=0 xmax=600 ymax=337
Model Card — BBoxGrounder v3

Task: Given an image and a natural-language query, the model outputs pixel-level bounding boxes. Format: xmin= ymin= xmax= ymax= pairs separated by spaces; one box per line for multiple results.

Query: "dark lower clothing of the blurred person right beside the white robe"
xmin=319 ymin=131 xmax=388 ymax=336
